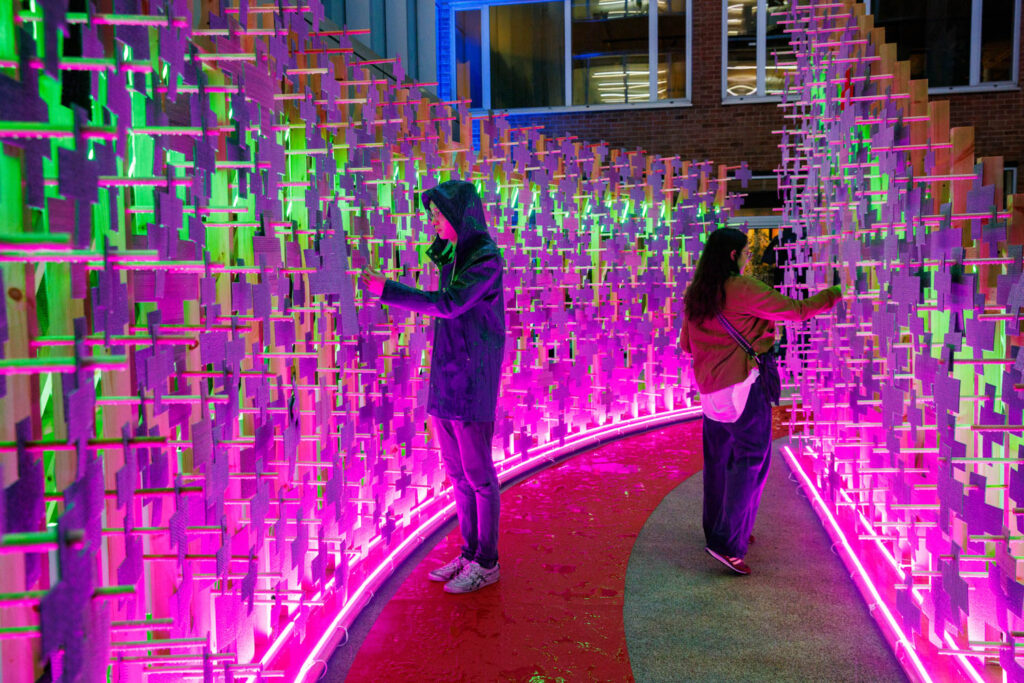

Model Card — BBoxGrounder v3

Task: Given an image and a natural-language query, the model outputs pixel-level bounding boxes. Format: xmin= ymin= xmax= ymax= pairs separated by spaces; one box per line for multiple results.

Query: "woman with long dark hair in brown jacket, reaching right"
xmin=679 ymin=227 xmax=842 ymax=574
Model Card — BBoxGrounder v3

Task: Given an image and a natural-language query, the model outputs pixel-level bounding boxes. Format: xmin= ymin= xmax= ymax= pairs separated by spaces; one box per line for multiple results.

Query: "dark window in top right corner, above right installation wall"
xmin=873 ymin=0 xmax=1016 ymax=87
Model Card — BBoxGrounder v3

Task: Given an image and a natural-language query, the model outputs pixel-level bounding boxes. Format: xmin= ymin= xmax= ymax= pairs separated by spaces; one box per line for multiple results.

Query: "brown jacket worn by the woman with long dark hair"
xmin=679 ymin=275 xmax=842 ymax=393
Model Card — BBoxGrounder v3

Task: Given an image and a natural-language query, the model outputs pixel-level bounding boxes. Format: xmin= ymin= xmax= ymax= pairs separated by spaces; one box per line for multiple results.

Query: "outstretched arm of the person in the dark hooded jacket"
xmin=381 ymin=253 xmax=502 ymax=317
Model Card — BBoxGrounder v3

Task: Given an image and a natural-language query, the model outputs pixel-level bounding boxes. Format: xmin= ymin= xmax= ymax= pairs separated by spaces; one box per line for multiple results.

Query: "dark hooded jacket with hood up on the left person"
xmin=381 ymin=180 xmax=505 ymax=422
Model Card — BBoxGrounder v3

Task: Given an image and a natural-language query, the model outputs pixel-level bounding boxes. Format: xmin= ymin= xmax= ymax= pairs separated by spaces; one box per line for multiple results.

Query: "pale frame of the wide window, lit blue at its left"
xmin=446 ymin=0 xmax=694 ymax=116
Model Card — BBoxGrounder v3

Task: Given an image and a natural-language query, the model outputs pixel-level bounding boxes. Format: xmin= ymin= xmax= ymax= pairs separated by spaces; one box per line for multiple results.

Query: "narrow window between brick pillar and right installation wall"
xmin=723 ymin=0 xmax=793 ymax=98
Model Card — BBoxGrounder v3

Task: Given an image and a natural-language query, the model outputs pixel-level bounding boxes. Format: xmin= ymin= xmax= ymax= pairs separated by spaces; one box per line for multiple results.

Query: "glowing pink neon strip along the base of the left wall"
xmin=290 ymin=405 xmax=700 ymax=681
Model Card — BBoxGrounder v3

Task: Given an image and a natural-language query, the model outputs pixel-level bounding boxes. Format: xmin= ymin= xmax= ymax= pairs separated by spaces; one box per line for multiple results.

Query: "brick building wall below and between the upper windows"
xmin=501 ymin=0 xmax=1024 ymax=179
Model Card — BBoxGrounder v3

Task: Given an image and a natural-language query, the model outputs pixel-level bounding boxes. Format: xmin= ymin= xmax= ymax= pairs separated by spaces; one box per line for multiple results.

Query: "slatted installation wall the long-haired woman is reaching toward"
xmin=779 ymin=0 xmax=1024 ymax=681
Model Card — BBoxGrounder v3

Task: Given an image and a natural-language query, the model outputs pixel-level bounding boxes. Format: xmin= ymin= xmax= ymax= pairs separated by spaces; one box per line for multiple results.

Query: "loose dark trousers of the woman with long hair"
xmin=703 ymin=379 xmax=771 ymax=557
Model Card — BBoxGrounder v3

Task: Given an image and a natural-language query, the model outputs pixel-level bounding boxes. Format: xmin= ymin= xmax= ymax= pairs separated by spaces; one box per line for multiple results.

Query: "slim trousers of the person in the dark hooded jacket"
xmin=431 ymin=416 xmax=501 ymax=568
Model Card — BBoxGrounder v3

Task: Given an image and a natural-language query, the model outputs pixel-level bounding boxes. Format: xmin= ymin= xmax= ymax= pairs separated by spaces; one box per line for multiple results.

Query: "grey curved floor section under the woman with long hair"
xmin=624 ymin=439 xmax=907 ymax=682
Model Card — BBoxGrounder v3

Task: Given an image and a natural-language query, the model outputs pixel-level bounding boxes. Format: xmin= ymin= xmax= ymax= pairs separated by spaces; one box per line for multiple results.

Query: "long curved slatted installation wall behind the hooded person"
xmin=0 ymin=0 xmax=748 ymax=682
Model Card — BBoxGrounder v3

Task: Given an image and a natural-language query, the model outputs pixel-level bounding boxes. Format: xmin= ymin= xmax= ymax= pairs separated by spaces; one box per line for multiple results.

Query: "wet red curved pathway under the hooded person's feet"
xmin=346 ymin=416 xmax=781 ymax=683
